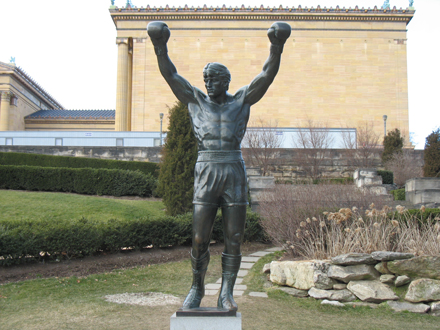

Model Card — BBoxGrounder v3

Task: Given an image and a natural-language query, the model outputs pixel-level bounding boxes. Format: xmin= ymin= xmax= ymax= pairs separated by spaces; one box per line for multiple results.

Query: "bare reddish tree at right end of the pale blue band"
xmin=342 ymin=121 xmax=382 ymax=168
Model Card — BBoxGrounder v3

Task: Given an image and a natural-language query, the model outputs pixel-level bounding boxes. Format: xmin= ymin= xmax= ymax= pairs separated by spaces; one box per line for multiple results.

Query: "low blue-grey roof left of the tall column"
xmin=25 ymin=109 xmax=115 ymax=120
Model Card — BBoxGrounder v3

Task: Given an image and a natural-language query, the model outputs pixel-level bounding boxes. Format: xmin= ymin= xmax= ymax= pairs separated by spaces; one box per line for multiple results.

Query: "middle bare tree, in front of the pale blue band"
xmin=293 ymin=119 xmax=333 ymax=180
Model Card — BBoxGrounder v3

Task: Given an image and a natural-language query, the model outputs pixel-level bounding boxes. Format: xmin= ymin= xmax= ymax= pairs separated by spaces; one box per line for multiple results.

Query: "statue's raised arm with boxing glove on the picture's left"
xmin=147 ymin=22 xmax=194 ymax=105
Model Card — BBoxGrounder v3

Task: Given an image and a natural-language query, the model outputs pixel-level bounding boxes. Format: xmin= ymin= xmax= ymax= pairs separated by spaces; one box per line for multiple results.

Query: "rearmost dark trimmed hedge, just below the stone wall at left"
xmin=0 ymin=152 xmax=159 ymax=178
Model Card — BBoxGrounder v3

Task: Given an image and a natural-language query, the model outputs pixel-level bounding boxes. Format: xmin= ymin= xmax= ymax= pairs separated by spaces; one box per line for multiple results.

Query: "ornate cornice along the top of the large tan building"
xmin=110 ymin=5 xmax=415 ymax=25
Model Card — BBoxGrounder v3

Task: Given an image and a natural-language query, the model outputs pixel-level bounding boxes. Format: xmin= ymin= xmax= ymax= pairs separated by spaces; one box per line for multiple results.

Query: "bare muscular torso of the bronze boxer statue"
xmin=188 ymin=87 xmax=250 ymax=151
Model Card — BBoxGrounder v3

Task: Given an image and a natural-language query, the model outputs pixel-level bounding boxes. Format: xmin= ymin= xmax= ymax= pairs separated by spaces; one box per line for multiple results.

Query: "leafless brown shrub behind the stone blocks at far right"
xmin=385 ymin=149 xmax=423 ymax=187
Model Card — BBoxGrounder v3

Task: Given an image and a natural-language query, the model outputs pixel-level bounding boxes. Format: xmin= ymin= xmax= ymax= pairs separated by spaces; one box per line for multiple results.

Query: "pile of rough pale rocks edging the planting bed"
xmin=264 ymin=251 xmax=440 ymax=316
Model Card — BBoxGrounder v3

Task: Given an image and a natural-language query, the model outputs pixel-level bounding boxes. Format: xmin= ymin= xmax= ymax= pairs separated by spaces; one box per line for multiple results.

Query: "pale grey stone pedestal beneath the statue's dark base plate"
xmin=170 ymin=313 xmax=241 ymax=330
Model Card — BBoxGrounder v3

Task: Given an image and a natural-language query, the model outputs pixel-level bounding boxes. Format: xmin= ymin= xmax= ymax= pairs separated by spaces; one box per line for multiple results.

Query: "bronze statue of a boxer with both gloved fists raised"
xmin=147 ymin=22 xmax=291 ymax=310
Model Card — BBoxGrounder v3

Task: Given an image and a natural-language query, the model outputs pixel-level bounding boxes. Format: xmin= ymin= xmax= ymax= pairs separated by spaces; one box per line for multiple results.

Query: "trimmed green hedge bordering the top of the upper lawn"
xmin=0 ymin=165 xmax=157 ymax=196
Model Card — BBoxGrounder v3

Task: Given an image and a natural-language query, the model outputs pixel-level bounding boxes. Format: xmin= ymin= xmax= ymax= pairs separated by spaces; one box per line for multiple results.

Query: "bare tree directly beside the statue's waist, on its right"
xmin=242 ymin=118 xmax=283 ymax=175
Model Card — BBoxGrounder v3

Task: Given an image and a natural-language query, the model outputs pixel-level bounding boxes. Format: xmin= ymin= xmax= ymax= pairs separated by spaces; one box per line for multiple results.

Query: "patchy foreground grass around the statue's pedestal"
xmin=0 ymin=255 xmax=440 ymax=330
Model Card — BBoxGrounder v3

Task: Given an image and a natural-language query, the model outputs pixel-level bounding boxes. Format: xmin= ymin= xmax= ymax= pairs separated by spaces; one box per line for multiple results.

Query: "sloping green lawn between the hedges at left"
xmin=0 ymin=190 xmax=165 ymax=220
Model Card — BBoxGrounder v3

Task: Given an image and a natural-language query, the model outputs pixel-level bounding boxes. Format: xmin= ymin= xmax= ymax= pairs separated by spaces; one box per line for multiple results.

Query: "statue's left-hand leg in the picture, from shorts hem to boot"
xmin=182 ymin=204 xmax=217 ymax=309
